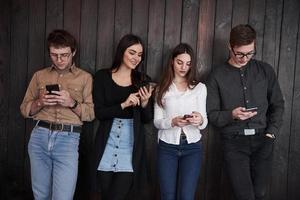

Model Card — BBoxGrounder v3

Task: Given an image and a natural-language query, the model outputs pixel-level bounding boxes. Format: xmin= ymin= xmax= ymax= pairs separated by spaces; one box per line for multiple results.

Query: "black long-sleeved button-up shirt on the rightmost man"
xmin=207 ymin=59 xmax=284 ymax=134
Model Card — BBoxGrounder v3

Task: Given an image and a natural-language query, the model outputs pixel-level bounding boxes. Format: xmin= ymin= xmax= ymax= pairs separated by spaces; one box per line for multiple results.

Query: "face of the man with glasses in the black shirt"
xmin=229 ymin=42 xmax=255 ymax=67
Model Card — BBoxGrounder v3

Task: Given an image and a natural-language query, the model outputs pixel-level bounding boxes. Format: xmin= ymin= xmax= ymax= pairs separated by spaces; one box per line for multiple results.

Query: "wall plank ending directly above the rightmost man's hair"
xmin=232 ymin=0 xmax=250 ymax=27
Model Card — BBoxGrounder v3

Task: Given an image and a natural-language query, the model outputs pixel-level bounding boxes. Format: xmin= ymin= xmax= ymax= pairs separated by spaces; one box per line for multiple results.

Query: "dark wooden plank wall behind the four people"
xmin=0 ymin=0 xmax=300 ymax=200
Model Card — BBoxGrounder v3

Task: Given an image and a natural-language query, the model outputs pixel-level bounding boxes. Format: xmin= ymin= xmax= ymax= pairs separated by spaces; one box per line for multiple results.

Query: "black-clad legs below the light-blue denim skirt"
xmin=97 ymin=171 xmax=133 ymax=200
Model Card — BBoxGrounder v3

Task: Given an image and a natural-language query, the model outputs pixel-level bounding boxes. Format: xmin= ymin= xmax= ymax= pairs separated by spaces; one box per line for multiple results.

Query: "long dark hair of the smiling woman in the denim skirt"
xmin=110 ymin=34 xmax=145 ymax=85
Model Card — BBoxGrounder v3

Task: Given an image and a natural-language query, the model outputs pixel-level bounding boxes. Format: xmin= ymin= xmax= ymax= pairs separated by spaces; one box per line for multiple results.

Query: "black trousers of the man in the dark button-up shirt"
xmin=222 ymin=134 xmax=274 ymax=200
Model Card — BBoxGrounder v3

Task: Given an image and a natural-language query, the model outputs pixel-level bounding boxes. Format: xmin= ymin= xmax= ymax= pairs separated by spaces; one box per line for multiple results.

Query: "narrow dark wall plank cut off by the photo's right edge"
xmin=287 ymin=7 xmax=300 ymax=200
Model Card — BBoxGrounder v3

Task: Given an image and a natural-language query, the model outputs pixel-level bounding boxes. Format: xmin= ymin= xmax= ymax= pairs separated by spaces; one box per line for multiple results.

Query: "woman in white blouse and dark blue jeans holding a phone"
xmin=154 ymin=43 xmax=207 ymax=200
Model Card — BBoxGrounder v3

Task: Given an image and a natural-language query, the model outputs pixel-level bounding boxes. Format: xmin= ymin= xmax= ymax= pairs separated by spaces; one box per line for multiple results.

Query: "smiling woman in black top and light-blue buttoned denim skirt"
xmin=93 ymin=34 xmax=153 ymax=200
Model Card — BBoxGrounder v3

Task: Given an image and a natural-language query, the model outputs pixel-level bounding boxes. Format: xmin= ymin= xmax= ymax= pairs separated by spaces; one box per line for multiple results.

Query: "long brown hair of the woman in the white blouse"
xmin=156 ymin=43 xmax=199 ymax=107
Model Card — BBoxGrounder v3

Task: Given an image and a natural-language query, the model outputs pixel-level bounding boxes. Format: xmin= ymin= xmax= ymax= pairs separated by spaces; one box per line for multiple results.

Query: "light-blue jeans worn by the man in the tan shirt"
xmin=28 ymin=126 xmax=80 ymax=200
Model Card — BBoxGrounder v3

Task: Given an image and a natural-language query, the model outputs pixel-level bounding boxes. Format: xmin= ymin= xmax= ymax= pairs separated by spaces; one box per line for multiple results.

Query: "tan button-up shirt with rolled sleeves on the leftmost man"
xmin=20 ymin=65 xmax=95 ymax=125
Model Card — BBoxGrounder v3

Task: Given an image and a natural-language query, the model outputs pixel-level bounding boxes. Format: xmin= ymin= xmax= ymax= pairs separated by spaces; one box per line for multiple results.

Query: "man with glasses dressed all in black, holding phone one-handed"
xmin=207 ymin=25 xmax=284 ymax=200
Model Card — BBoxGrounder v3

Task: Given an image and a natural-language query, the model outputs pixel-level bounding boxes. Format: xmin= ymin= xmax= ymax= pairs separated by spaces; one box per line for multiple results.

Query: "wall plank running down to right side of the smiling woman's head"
xmin=132 ymin=0 xmax=149 ymax=69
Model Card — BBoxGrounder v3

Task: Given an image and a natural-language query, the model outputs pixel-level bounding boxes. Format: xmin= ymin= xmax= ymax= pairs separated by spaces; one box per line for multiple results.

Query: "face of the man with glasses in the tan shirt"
xmin=49 ymin=47 xmax=75 ymax=71
